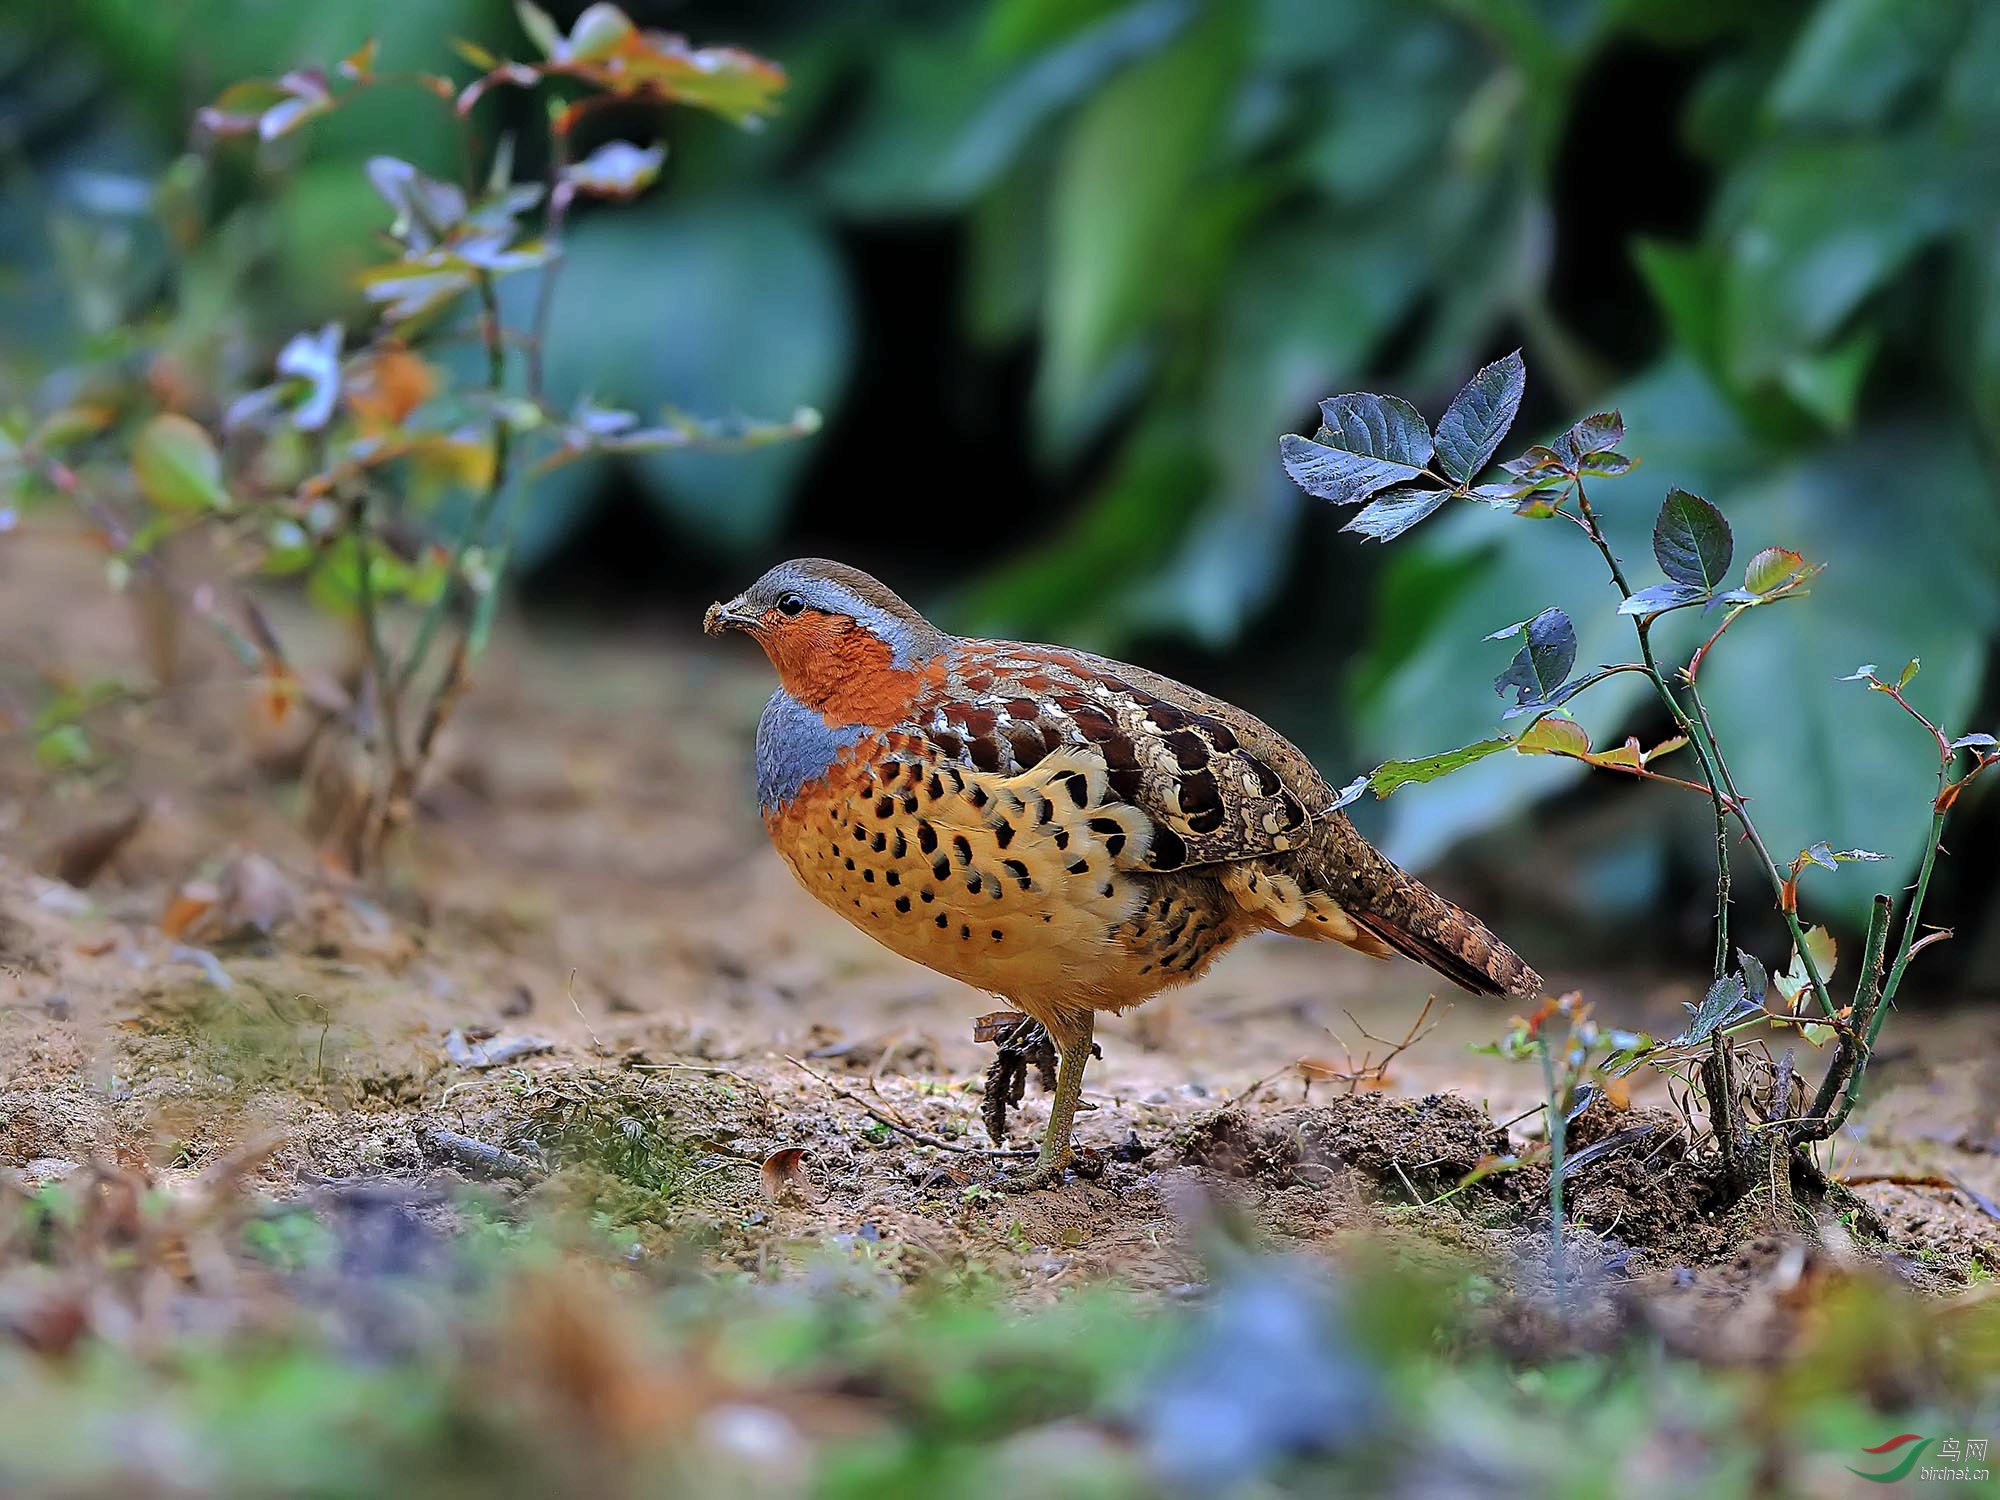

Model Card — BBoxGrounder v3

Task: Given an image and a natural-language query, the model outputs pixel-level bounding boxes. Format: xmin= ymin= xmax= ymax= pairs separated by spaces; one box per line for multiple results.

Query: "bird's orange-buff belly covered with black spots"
xmin=764 ymin=736 xmax=1236 ymax=1012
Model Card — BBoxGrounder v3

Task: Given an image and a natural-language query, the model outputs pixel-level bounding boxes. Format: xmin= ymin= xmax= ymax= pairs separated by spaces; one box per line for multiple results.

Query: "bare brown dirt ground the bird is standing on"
xmin=0 ymin=530 xmax=2000 ymax=1338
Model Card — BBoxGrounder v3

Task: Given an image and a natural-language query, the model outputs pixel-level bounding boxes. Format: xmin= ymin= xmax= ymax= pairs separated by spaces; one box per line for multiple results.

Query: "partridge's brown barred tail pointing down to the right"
xmin=1314 ymin=812 xmax=1542 ymax=998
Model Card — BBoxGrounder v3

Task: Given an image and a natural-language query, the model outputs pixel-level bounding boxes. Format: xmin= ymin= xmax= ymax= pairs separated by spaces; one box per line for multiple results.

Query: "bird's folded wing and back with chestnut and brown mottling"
xmin=910 ymin=642 xmax=1332 ymax=870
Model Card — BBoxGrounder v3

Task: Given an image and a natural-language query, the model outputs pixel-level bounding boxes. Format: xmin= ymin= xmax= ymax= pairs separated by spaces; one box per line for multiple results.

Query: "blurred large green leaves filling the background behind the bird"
xmin=0 ymin=0 xmax=2000 ymax=902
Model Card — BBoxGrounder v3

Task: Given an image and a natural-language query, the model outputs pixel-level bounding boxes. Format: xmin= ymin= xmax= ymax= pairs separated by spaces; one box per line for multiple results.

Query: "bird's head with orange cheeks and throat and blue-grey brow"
xmin=702 ymin=558 xmax=950 ymax=724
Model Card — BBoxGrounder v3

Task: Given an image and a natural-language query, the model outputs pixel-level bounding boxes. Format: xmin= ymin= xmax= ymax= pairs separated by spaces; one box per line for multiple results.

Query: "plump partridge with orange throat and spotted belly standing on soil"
xmin=702 ymin=558 xmax=1542 ymax=1186
